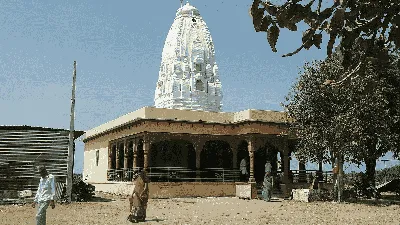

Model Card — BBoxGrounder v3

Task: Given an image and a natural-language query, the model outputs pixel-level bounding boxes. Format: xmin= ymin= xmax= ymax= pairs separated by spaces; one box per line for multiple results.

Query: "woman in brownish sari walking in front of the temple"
xmin=128 ymin=170 xmax=150 ymax=222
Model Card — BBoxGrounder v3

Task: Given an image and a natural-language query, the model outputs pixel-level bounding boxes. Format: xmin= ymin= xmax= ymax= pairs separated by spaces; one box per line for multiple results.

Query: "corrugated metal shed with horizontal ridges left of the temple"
xmin=0 ymin=126 xmax=84 ymax=198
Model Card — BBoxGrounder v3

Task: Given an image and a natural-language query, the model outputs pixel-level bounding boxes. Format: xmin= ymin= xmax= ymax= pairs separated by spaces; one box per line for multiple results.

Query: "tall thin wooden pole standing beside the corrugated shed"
xmin=67 ymin=61 xmax=76 ymax=202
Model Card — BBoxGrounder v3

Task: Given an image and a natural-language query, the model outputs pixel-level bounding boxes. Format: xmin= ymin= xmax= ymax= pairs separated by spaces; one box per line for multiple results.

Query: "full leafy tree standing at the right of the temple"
xmin=285 ymin=51 xmax=400 ymax=195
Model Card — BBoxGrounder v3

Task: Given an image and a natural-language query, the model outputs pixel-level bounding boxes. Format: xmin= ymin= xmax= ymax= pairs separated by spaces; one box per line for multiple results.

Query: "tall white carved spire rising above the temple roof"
xmin=154 ymin=0 xmax=222 ymax=111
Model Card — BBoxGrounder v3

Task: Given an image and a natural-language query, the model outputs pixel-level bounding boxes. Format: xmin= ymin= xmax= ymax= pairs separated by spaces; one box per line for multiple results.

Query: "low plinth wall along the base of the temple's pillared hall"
xmin=90 ymin=182 xmax=245 ymax=198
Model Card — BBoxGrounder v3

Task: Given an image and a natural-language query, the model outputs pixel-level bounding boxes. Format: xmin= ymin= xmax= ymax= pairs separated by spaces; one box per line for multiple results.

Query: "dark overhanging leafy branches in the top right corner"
xmin=250 ymin=0 xmax=400 ymax=80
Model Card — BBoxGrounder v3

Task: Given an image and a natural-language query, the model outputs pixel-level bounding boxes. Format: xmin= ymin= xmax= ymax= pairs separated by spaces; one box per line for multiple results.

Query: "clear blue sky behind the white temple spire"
xmin=0 ymin=0 xmax=396 ymax=172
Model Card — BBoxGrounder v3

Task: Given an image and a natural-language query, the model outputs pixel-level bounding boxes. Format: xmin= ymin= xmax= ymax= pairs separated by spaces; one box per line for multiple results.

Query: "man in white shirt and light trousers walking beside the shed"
xmin=32 ymin=166 xmax=56 ymax=225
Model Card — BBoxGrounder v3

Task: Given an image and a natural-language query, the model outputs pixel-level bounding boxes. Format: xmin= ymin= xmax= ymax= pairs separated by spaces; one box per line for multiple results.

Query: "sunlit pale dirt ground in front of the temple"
xmin=0 ymin=193 xmax=400 ymax=225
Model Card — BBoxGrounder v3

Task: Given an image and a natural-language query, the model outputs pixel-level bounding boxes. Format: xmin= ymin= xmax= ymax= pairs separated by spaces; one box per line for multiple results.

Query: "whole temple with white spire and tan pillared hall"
xmin=83 ymin=3 xmax=332 ymax=197
